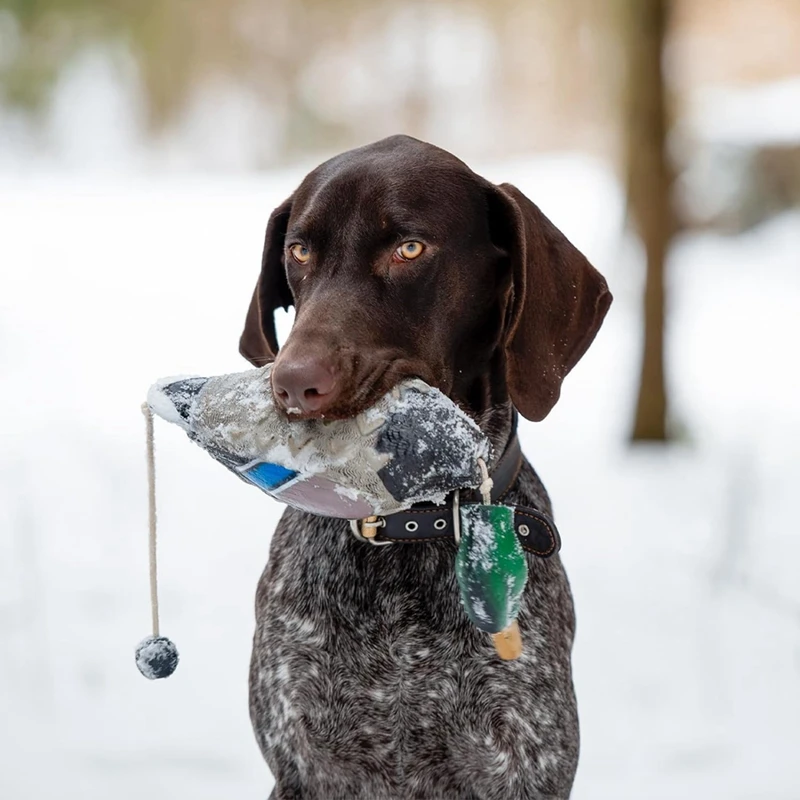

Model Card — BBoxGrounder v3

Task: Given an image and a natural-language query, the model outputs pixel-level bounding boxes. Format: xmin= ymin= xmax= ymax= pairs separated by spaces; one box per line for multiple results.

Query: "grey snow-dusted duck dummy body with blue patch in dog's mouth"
xmin=147 ymin=365 xmax=490 ymax=519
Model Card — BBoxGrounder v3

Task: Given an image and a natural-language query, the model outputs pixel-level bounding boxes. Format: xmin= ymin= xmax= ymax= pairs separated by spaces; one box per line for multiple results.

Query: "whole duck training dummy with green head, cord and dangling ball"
xmin=136 ymin=365 xmax=527 ymax=679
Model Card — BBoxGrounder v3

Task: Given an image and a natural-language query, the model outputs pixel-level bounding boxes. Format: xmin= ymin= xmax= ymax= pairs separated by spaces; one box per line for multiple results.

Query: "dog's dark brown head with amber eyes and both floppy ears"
xmin=240 ymin=136 xmax=611 ymax=420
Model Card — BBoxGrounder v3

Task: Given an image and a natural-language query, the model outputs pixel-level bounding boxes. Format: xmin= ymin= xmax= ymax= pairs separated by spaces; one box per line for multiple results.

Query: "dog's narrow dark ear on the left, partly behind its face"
xmin=239 ymin=197 xmax=294 ymax=367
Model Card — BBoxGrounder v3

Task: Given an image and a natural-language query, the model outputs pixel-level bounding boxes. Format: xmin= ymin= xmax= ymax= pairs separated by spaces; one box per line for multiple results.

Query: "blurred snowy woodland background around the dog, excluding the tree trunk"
xmin=0 ymin=0 xmax=800 ymax=800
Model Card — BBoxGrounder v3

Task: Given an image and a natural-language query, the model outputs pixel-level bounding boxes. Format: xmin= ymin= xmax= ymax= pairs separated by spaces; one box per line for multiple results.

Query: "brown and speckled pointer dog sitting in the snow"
xmin=240 ymin=136 xmax=612 ymax=800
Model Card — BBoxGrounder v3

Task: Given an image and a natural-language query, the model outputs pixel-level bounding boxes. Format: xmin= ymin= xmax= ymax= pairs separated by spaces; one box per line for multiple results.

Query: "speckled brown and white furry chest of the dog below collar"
xmin=251 ymin=494 xmax=574 ymax=800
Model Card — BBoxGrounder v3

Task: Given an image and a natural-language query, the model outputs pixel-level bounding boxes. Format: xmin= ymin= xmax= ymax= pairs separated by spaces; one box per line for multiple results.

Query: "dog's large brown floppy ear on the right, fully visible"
xmin=490 ymin=183 xmax=612 ymax=421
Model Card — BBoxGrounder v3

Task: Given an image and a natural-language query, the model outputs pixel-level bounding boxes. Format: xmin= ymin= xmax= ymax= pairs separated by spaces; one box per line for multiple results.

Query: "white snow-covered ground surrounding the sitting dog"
xmin=0 ymin=156 xmax=800 ymax=800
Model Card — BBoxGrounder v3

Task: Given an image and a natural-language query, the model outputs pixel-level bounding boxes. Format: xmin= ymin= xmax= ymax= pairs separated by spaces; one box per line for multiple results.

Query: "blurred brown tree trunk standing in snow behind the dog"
xmin=621 ymin=0 xmax=674 ymax=441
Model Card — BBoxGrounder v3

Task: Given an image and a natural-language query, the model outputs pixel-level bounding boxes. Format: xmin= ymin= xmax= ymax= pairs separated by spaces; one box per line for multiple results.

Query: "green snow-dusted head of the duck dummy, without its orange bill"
xmin=456 ymin=505 xmax=528 ymax=644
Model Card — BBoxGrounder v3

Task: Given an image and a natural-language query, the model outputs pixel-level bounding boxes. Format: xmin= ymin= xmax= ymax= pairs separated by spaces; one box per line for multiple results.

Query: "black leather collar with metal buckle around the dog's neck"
xmin=353 ymin=420 xmax=561 ymax=558
